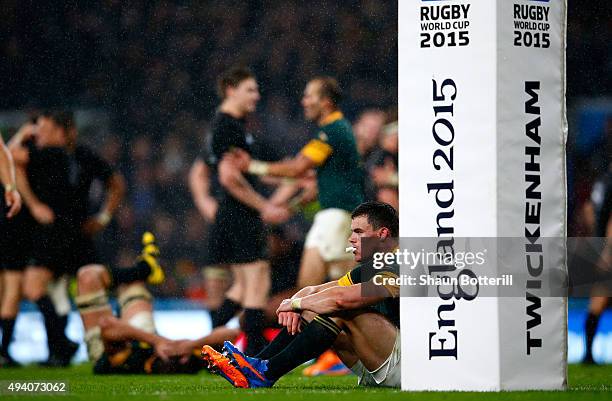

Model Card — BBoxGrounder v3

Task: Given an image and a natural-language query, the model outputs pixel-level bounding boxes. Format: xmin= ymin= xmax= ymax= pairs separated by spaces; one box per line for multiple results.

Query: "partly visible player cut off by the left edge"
xmin=0 ymin=136 xmax=21 ymax=367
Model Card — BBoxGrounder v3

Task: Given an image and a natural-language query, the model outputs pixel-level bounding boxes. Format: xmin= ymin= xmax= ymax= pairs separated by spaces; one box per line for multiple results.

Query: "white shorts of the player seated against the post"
xmin=351 ymin=330 xmax=402 ymax=388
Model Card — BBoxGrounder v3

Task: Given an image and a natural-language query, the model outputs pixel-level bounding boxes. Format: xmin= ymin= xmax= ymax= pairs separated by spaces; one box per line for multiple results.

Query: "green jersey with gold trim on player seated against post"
xmin=338 ymin=260 xmax=400 ymax=327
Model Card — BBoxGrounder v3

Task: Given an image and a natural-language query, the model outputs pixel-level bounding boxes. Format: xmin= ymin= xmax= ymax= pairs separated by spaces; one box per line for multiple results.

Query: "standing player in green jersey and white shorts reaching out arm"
xmin=227 ymin=77 xmax=364 ymax=288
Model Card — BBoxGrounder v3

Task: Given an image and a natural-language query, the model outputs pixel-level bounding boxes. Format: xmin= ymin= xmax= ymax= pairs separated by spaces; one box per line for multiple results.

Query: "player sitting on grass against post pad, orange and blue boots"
xmin=202 ymin=202 xmax=400 ymax=388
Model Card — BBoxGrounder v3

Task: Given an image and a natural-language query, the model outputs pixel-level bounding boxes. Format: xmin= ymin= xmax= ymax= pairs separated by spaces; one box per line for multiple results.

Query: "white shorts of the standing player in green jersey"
xmin=304 ymin=209 xmax=353 ymax=262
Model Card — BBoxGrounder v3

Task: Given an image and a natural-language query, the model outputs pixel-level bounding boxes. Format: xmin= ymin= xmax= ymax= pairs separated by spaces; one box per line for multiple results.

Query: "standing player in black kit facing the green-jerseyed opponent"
xmin=208 ymin=68 xmax=289 ymax=352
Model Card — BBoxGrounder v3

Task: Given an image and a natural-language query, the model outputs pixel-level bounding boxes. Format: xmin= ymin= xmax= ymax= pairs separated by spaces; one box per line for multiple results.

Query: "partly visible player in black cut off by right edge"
xmin=583 ymin=164 xmax=612 ymax=364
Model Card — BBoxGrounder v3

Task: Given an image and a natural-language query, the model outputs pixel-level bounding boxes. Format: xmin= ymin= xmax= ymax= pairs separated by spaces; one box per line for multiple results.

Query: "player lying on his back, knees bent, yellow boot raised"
xmin=76 ymin=233 xmax=235 ymax=374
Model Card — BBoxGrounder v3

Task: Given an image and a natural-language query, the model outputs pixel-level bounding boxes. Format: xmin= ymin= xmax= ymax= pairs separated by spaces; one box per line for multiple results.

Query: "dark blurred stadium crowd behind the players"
xmin=0 ymin=0 xmax=612 ymax=299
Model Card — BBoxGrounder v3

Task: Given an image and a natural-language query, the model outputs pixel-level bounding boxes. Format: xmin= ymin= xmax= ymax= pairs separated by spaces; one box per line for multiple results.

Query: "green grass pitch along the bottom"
xmin=0 ymin=364 xmax=612 ymax=401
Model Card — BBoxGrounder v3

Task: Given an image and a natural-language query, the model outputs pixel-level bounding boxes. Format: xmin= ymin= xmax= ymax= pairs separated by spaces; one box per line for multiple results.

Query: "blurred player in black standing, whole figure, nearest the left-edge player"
xmin=9 ymin=115 xmax=78 ymax=360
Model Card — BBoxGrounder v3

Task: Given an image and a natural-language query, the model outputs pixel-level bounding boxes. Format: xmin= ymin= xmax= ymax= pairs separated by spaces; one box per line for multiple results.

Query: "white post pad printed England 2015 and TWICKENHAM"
xmin=398 ymin=0 xmax=567 ymax=391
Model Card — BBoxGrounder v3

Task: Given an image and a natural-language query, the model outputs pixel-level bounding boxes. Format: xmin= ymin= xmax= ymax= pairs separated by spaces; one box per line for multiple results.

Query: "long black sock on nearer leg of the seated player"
xmin=264 ymin=316 xmax=341 ymax=380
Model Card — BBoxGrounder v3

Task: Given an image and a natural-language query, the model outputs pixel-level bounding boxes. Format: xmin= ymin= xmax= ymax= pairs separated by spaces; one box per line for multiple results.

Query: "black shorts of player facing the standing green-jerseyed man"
xmin=206 ymin=204 xmax=267 ymax=265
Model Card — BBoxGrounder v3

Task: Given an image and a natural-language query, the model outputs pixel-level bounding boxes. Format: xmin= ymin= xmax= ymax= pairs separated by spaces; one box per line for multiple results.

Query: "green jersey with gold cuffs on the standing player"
xmin=301 ymin=111 xmax=364 ymax=212
